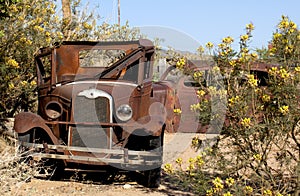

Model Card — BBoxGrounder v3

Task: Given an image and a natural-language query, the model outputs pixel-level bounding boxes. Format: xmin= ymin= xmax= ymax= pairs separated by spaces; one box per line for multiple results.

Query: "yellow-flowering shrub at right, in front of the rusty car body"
xmin=165 ymin=16 xmax=300 ymax=195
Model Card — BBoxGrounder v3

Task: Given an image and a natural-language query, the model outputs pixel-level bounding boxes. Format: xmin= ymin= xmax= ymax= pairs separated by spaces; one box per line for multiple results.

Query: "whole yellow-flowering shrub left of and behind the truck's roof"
xmin=0 ymin=0 xmax=140 ymax=124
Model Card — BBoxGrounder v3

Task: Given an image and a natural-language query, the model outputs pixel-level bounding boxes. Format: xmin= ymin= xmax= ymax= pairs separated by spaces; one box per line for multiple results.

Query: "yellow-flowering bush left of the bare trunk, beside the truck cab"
xmin=0 ymin=0 xmax=58 ymax=121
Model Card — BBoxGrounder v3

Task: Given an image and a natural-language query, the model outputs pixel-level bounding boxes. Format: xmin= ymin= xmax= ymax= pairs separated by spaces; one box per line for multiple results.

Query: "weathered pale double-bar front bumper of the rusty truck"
xmin=21 ymin=142 xmax=162 ymax=167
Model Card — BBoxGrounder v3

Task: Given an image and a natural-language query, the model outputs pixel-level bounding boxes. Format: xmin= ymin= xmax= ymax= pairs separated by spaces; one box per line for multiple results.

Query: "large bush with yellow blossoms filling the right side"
xmin=202 ymin=16 xmax=300 ymax=195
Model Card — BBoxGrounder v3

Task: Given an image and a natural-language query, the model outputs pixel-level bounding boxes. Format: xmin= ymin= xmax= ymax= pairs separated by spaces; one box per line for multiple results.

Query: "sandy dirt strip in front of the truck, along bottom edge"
xmin=11 ymin=179 xmax=180 ymax=196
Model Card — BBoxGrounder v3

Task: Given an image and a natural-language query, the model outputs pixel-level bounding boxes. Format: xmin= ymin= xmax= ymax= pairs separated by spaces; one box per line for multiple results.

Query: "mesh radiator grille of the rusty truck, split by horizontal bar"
xmin=72 ymin=96 xmax=110 ymax=148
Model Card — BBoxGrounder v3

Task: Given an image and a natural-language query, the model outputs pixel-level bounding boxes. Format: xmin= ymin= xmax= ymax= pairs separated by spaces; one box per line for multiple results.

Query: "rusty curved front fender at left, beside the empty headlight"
xmin=14 ymin=112 xmax=59 ymax=145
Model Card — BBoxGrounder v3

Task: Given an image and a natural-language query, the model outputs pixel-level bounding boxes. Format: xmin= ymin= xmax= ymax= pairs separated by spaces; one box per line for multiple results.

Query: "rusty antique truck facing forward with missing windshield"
xmin=14 ymin=39 xmax=188 ymax=187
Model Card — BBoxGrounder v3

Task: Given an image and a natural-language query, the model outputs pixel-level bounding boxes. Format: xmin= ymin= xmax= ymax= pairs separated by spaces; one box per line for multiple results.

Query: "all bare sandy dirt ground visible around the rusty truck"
xmin=0 ymin=133 xmax=217 ymax=196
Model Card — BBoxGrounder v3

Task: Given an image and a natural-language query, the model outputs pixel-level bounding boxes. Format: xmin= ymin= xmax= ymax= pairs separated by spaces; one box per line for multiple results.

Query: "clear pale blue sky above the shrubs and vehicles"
xmin=81 ymin=0 xmax=300 ymax=51
